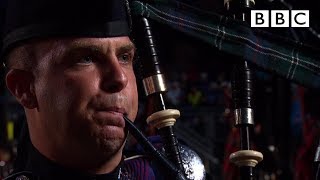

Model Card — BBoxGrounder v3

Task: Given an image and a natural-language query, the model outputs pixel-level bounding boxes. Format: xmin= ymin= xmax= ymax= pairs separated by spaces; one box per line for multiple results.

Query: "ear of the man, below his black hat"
xmin=6 ymin=69 xmax=38 ymax=109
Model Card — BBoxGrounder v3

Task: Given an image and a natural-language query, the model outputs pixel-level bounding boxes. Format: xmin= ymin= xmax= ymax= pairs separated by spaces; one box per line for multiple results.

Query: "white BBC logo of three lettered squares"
xmin=251 ymin=10 xmax=309 ymax=27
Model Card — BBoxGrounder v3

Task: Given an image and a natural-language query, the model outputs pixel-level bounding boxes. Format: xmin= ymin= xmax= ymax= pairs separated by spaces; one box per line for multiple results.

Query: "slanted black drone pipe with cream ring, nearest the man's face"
xmin=132 ymin=16 xmax=184 ymax=178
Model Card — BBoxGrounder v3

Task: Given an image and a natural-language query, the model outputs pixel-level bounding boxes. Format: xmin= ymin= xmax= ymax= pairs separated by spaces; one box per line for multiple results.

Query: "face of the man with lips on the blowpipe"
xmin=34 ymin=37 xmax=138 ymax=160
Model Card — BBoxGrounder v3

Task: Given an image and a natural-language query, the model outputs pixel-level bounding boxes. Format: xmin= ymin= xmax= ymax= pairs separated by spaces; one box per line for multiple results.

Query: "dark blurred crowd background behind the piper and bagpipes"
xmin=0 ymin=0 xmax=320 ymax=180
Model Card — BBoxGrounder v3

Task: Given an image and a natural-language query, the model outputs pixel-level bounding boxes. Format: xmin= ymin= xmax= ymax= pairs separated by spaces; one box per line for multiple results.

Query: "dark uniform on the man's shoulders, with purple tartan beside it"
xmin=6 ymin=139 xmax=164 ymax=180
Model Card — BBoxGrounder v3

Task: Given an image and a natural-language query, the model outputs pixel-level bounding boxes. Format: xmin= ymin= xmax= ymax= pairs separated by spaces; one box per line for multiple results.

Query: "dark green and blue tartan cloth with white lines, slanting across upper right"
xmin=131 ymin=0 xmax=320 ymax=88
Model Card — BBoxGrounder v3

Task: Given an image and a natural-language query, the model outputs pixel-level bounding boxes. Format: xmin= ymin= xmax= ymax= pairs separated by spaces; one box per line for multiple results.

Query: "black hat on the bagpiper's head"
xmin=2 ymin=0 xmax=130 ymax=60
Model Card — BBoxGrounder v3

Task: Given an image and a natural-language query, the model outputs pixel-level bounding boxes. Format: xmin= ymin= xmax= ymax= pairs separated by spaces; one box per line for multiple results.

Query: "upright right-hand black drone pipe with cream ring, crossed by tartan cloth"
xmin=225 ymin=0 xmax=263 ymax=180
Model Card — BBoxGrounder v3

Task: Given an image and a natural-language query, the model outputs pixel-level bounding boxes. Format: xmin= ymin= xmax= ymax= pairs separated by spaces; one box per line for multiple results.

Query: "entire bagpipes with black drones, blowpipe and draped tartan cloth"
xmin=125 ymin=0 xmax=320 ymax=180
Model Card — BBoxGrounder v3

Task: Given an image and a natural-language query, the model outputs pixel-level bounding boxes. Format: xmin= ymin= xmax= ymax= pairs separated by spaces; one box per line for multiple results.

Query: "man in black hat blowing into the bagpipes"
xmin=2 ymin=0 xmax=154 ymax=179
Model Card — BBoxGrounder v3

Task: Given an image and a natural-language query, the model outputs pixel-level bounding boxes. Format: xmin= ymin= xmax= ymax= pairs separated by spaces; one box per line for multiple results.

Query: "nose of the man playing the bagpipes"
xmin=101 ymin=57 xmax=128 ymax=93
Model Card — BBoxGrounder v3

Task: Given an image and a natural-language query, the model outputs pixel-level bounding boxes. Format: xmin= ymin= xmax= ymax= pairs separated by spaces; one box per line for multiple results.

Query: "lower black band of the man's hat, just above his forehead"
xmin=1 ymin=21 xmax=130 ymax=54
